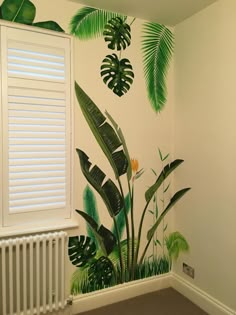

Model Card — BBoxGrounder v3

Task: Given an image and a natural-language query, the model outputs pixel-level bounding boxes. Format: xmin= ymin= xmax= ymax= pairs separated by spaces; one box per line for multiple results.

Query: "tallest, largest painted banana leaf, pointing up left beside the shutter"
xmin=75 ymin=82 xmax=128 ymax=178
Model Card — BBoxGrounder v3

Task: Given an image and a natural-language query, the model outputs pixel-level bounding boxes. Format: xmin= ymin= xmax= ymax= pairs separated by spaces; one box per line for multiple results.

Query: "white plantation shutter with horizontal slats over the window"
xmin=1 ymin=27 xmax=71 ymax=225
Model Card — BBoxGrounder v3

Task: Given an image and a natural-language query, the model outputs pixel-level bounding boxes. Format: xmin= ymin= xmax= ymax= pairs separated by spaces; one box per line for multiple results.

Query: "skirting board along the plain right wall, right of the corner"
xmin=170 ymin=273 xmax=236 ymax=315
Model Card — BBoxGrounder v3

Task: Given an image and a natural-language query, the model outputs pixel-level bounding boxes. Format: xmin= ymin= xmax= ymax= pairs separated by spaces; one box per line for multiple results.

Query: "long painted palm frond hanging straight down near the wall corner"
xmin=142 ymin=22 xmax=174 ymax=112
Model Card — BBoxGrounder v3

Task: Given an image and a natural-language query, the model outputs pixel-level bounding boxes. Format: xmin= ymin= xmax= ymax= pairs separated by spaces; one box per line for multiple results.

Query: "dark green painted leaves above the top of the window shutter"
xmin=0 ymin=0 xmax=64 ymax=32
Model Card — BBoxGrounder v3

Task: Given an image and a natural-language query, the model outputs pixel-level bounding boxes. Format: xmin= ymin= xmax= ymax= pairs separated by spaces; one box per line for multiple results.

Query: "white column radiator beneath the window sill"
xmin=0 ymin=232 xmax=67 ymax=315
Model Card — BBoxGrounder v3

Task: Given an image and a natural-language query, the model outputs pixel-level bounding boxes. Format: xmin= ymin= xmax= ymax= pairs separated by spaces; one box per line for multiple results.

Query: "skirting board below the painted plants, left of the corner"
xmin=72 ymin=273 xmax=171 ymax=315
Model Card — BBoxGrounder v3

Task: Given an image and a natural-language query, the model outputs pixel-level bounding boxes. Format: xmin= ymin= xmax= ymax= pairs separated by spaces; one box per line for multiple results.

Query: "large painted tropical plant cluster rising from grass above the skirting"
xmin=68 ymin=83 xmax=190 ymax=293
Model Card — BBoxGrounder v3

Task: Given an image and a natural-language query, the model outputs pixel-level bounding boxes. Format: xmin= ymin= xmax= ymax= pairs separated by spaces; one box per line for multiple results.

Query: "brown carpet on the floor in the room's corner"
xmin=79 ymin=288 xmax=207 ymax=315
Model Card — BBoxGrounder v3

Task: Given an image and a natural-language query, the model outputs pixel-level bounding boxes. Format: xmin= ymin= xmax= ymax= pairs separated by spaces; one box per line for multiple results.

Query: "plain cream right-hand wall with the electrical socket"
xmin=174 ymin=0 xmax=236 ymax=309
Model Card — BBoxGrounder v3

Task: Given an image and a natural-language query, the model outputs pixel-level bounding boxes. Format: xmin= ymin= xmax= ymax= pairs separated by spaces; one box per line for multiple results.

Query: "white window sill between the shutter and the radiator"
xmin=0 ymin=220 xmax=78 ymax=238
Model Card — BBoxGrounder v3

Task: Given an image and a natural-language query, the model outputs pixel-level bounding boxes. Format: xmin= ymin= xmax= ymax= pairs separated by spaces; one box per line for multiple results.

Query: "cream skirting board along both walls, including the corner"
xmin=71 ymin=272 xmax=236 ymax=315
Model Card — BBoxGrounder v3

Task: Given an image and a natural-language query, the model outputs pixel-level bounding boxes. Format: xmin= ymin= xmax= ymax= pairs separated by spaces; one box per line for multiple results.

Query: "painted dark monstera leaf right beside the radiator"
xmin=68 ymin=235 xmax=96 ymax=267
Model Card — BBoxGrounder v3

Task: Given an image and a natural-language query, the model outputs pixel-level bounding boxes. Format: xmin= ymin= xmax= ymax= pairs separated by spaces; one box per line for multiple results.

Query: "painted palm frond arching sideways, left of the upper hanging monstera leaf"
xmin=70 ymin=7 xmax=121 ymax=40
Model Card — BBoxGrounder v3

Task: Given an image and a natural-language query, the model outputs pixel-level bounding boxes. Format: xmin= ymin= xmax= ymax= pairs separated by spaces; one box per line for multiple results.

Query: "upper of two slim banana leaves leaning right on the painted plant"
xmin=145 ymin=159 xmax=184 ymax=202
